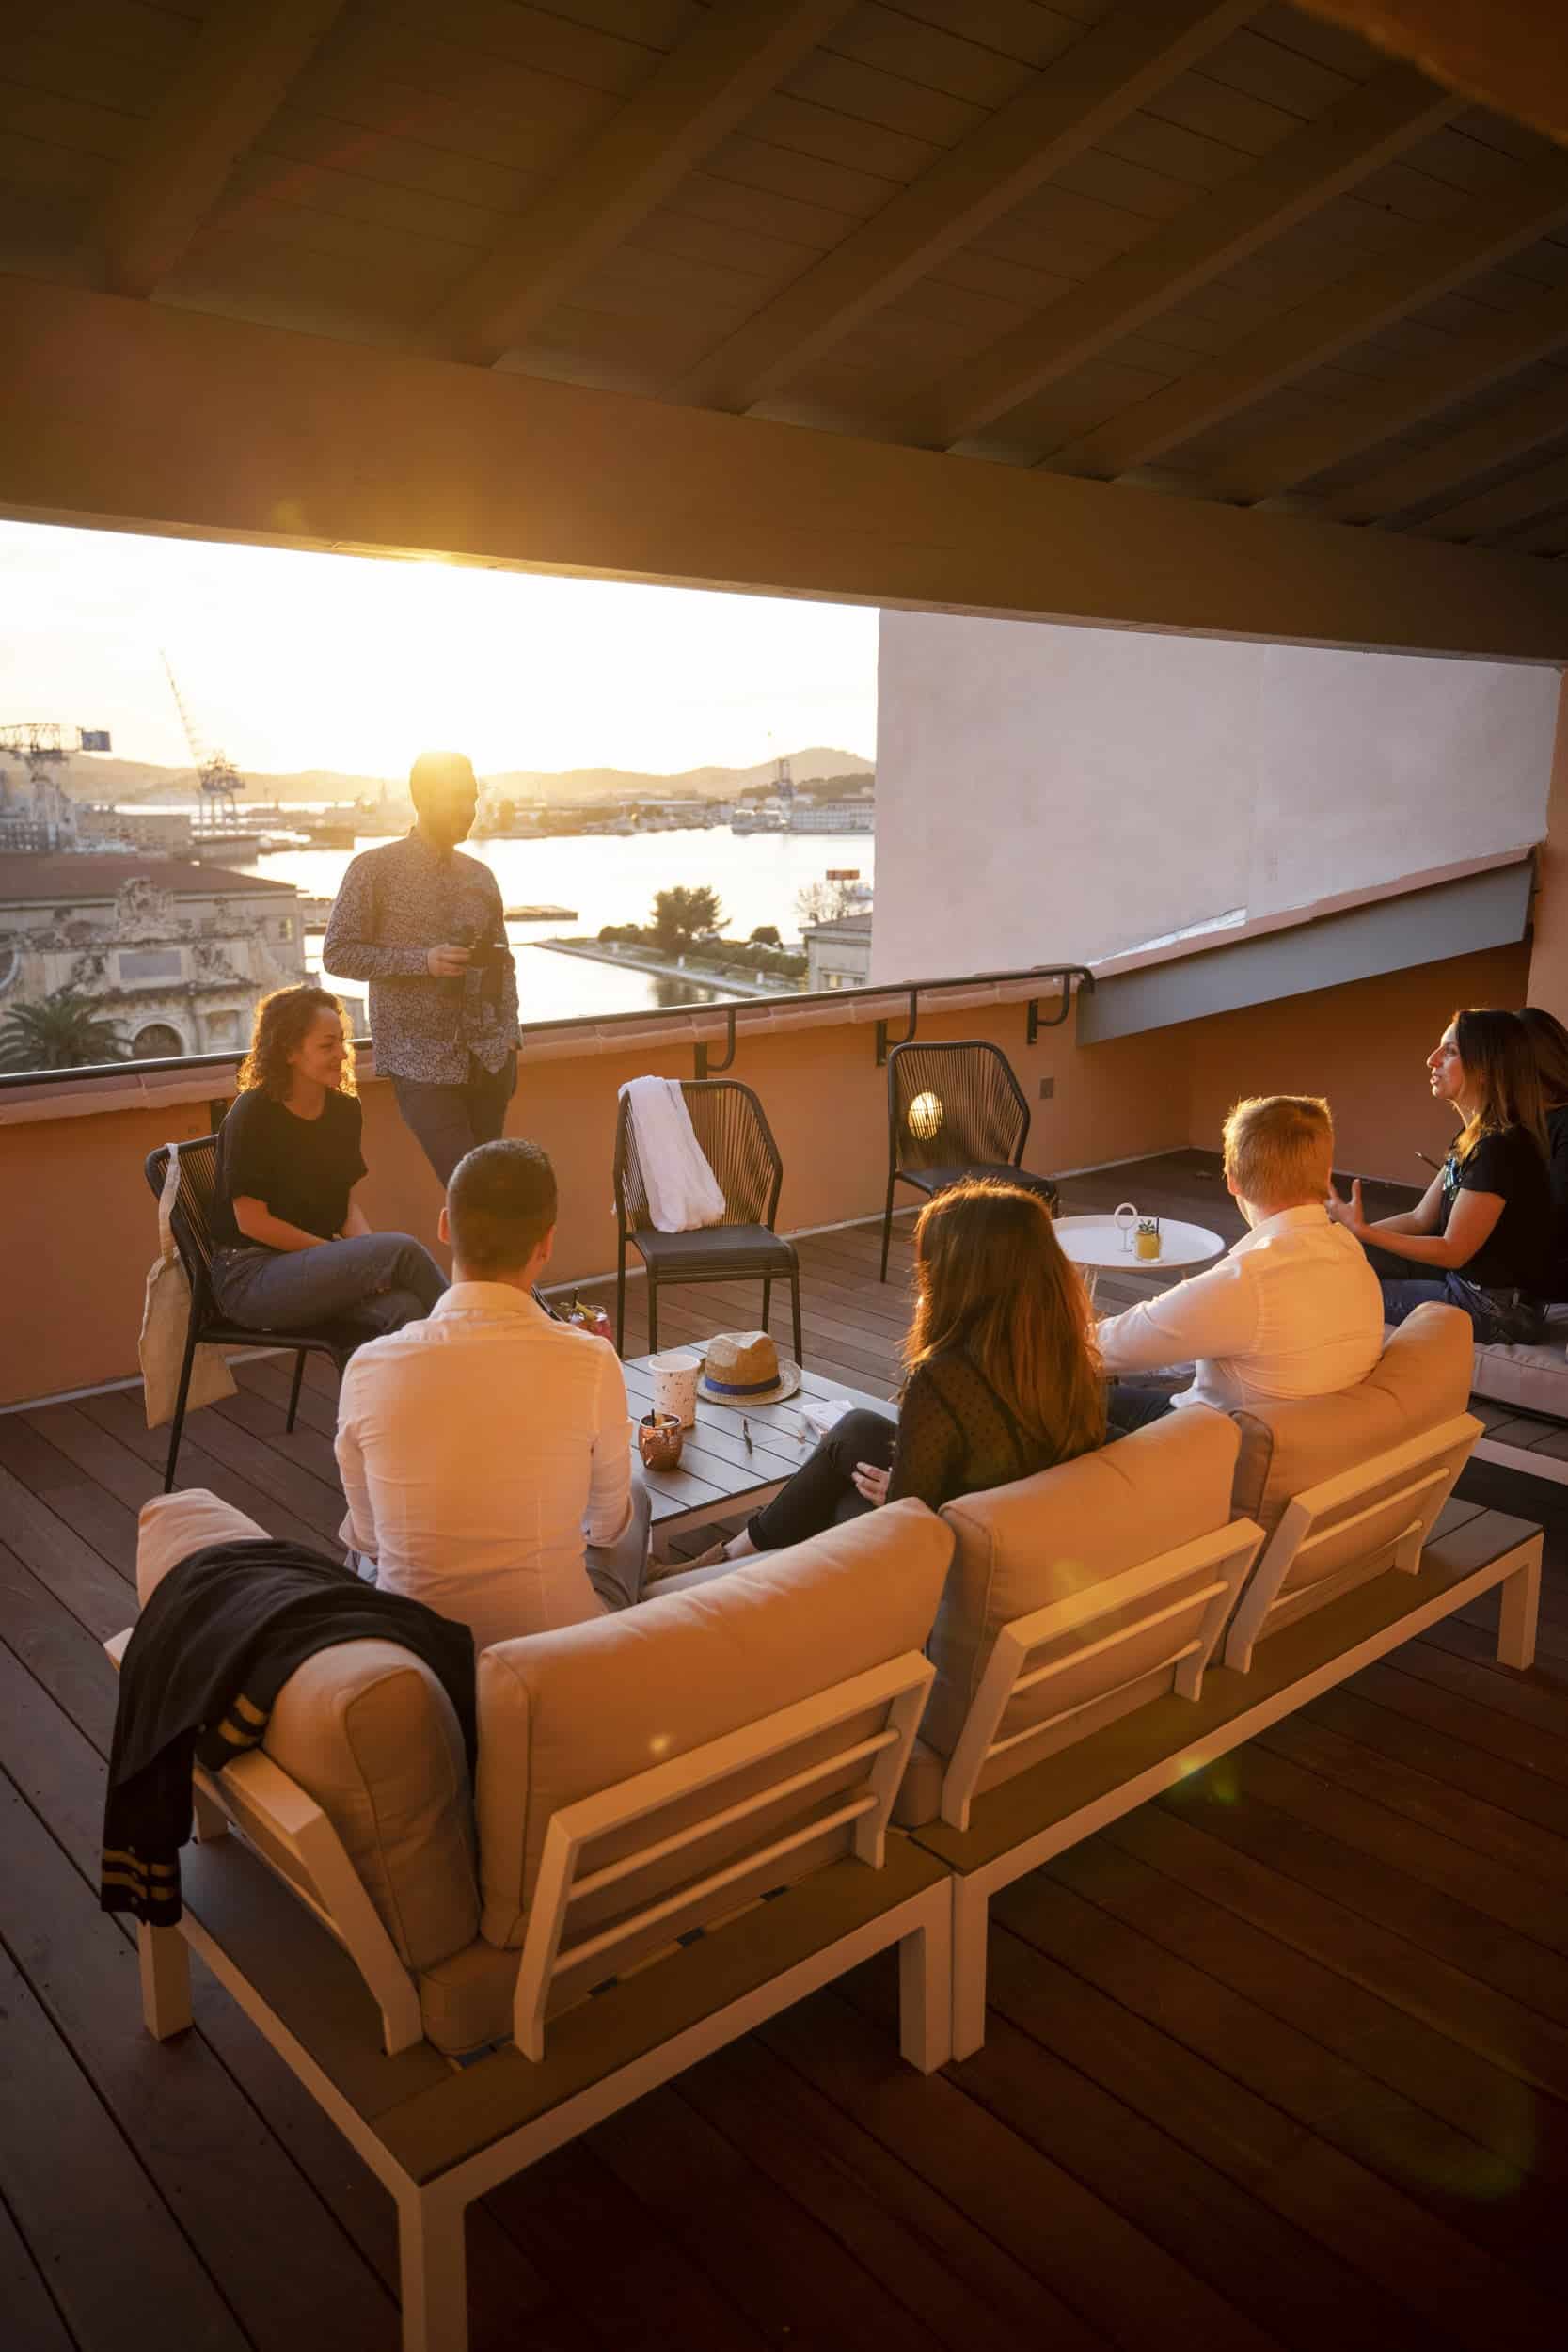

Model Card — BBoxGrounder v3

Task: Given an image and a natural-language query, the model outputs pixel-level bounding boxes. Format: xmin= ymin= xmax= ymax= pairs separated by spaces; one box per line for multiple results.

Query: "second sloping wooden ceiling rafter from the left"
xmin=428 ymin=0 xmax=844 ymax=367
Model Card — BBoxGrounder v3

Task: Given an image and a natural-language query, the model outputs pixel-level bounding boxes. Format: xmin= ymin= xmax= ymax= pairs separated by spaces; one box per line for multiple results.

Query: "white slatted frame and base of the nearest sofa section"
xmin=105 ymin=1632 xmax=952 ymax=2352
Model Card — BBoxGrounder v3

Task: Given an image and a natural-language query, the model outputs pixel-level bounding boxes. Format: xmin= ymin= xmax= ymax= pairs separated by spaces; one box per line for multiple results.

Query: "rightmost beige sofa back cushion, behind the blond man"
xmin=1232 ymin=1301 xmax=1486 ymax=1536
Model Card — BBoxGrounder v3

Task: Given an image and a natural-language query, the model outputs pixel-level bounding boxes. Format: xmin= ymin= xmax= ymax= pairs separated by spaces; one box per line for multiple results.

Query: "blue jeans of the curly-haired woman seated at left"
xmin=212 ymin=1232 xmax=447 ymax=1345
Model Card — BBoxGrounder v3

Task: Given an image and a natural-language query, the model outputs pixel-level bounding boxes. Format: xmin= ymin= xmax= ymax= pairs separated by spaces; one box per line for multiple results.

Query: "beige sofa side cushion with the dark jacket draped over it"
xmin=136 ymin=1489 xmax=480 ymax=1969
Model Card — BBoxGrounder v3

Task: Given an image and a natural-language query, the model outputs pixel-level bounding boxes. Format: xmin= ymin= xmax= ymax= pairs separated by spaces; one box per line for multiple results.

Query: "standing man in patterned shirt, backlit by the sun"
xmin=322 ymin=751 xmax=517 ymax=1185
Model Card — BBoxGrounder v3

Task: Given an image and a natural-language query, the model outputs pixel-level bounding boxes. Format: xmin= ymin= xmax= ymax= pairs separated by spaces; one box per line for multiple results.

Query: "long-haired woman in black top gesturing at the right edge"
xmin=1328 ymin=1009 xmax=1557 ymax=1341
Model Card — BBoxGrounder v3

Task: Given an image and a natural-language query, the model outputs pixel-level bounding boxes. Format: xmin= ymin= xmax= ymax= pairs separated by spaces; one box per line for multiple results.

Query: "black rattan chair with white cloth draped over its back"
xmin=616 ymin=1077 xmax=800 ymax=1362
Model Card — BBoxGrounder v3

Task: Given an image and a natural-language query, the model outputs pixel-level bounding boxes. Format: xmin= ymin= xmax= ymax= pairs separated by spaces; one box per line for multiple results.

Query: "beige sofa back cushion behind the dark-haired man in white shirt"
xmin=477 ymin=1501 xmax=952 ymax=1994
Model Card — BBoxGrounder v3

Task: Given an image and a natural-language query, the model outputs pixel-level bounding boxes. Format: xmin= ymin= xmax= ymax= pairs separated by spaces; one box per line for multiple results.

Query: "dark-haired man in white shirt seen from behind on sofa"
xmin=336 ymin=1141 xmax=649 ymax=1649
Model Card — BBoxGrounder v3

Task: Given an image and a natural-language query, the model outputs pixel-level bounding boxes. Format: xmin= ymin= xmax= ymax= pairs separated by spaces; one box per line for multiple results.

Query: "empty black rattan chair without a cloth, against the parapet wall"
xmin=881 ymin=1038 xmax=1055 ymax=1282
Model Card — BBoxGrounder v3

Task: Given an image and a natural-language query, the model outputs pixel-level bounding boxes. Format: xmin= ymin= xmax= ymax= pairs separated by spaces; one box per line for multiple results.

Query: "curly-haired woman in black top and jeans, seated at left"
xmin=212 ymin=986 xmax=447 ymax=1353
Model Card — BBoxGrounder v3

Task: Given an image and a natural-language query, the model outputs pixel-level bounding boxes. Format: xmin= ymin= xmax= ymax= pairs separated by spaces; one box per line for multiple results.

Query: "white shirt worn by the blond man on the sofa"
xmin=1101 ymin=1207 xmax=1383 ymax=1414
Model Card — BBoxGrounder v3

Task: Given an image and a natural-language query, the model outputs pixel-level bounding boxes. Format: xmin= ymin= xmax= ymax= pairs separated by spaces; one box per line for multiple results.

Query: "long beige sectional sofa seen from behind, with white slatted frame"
xmin=110 ymin=1308 xmax=1540 ymax=2352
